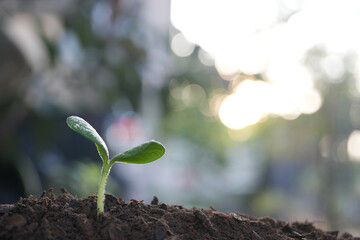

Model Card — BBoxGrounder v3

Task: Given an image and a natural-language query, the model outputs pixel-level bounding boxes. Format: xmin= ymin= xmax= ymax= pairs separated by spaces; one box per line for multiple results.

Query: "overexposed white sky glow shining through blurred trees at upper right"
xmin=171 ymin=0 xmax=360 ymax=129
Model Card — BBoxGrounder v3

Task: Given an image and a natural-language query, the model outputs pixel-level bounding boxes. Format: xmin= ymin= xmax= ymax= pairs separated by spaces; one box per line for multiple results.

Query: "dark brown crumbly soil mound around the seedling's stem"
xmin=0 ymin=189 xmax=360 ymax=240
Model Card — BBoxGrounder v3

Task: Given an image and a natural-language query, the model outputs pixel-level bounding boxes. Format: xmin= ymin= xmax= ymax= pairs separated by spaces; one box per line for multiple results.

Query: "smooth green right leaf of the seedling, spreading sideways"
xmin=111 ymin=140 xmax=165 ymax=164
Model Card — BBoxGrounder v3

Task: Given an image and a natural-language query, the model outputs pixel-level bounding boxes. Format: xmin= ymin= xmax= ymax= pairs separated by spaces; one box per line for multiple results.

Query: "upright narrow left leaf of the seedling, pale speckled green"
xmin=66 ymin=116 xmax=109 ymax=162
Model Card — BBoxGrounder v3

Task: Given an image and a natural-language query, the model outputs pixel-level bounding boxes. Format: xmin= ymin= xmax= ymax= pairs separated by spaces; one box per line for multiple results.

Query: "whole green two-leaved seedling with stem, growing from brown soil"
xmin=66 ymin=116 xmax=165 ymax=216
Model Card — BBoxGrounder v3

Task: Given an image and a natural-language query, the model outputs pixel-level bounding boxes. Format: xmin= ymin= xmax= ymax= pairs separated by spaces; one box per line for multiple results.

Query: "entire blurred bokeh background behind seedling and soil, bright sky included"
xmin=0 ymin=0 xmax=360 ymax=236
